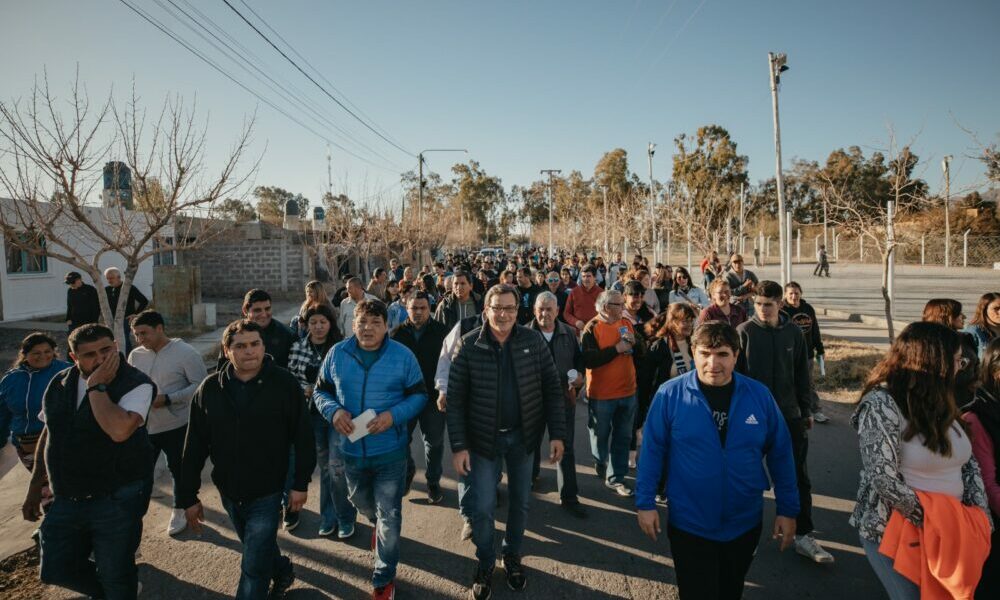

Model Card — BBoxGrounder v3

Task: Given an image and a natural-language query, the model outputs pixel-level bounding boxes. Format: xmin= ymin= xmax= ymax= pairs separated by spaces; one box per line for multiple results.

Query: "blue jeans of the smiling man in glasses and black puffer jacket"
xmin=469 ymin=429 xmax=533 ymax=567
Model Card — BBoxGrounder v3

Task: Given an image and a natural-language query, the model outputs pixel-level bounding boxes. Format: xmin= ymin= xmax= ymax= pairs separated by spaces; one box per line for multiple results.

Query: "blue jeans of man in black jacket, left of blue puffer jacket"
xmin=222 ymin=493 xmax=292 ymax=600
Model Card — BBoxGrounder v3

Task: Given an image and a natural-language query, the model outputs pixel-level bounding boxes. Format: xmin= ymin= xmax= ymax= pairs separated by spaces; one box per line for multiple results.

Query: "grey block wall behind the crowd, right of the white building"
xmin=178 ymin=223 xmax=309 ymax=299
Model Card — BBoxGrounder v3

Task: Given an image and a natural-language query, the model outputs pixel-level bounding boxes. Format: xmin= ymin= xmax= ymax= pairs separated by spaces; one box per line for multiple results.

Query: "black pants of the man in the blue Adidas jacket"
xmin=667 ymin=524 xmax=761 ymax=600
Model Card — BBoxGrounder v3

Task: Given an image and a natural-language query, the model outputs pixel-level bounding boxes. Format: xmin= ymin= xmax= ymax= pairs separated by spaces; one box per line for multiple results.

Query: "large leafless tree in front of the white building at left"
xmin=0 ymin=77 xmax=259 ymax=348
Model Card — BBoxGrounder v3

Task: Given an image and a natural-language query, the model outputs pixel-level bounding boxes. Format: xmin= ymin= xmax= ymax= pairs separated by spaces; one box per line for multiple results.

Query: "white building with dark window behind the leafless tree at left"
xmin=0 ymin=198 xmax=153 ymax=321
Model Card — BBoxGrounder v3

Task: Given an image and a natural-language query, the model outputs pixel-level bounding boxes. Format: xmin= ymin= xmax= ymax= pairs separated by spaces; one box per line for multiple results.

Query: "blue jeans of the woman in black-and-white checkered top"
xmin=312 ymin=413 xmax=358 ymax=529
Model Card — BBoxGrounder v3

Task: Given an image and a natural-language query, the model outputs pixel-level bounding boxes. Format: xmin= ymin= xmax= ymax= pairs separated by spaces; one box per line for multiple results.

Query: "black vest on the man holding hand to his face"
xmin=42 ymin=358 xmax=156 ymax=497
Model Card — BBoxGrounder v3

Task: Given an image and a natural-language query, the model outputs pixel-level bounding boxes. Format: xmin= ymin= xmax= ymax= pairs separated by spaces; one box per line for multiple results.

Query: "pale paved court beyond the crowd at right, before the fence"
xmin=751 ymin=264 xmax=1000 ymax=323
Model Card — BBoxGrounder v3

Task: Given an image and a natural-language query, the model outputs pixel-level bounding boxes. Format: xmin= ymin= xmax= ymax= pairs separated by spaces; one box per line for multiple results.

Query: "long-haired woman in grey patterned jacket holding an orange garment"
xmin=850 ymin=322 xmax=988 ymax=600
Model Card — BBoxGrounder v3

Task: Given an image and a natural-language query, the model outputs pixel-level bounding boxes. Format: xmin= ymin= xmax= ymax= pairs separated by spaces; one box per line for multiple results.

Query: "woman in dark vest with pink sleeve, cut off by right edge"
xmin=962 ymin=338 xmax=1000 ymax=600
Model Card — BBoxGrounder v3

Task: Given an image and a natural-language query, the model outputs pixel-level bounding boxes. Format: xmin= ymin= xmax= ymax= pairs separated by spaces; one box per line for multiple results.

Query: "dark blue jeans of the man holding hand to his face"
xmin=40 ymin=480 xmax=149 ymax=600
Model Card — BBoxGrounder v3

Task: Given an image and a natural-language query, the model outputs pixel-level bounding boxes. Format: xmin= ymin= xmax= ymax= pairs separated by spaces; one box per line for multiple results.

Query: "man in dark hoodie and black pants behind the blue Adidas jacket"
xmin=736 ymin=281 xmax=834 ymax=563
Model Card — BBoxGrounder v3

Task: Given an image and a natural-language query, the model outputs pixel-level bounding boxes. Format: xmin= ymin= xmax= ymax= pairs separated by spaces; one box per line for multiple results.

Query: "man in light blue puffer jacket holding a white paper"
xmin=313 ymin=300 xmax=427 ymax=600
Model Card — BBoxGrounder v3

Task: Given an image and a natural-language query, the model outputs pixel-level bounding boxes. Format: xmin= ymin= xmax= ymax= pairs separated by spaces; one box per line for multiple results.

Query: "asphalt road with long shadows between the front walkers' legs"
xmin=29 ymin=386 xmax=882 ymax=600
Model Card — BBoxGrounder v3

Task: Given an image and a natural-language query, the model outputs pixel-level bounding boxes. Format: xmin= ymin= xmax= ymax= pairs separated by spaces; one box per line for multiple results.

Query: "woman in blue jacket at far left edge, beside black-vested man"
xmin=0 ymin=332 xmax=72 ymax=471
